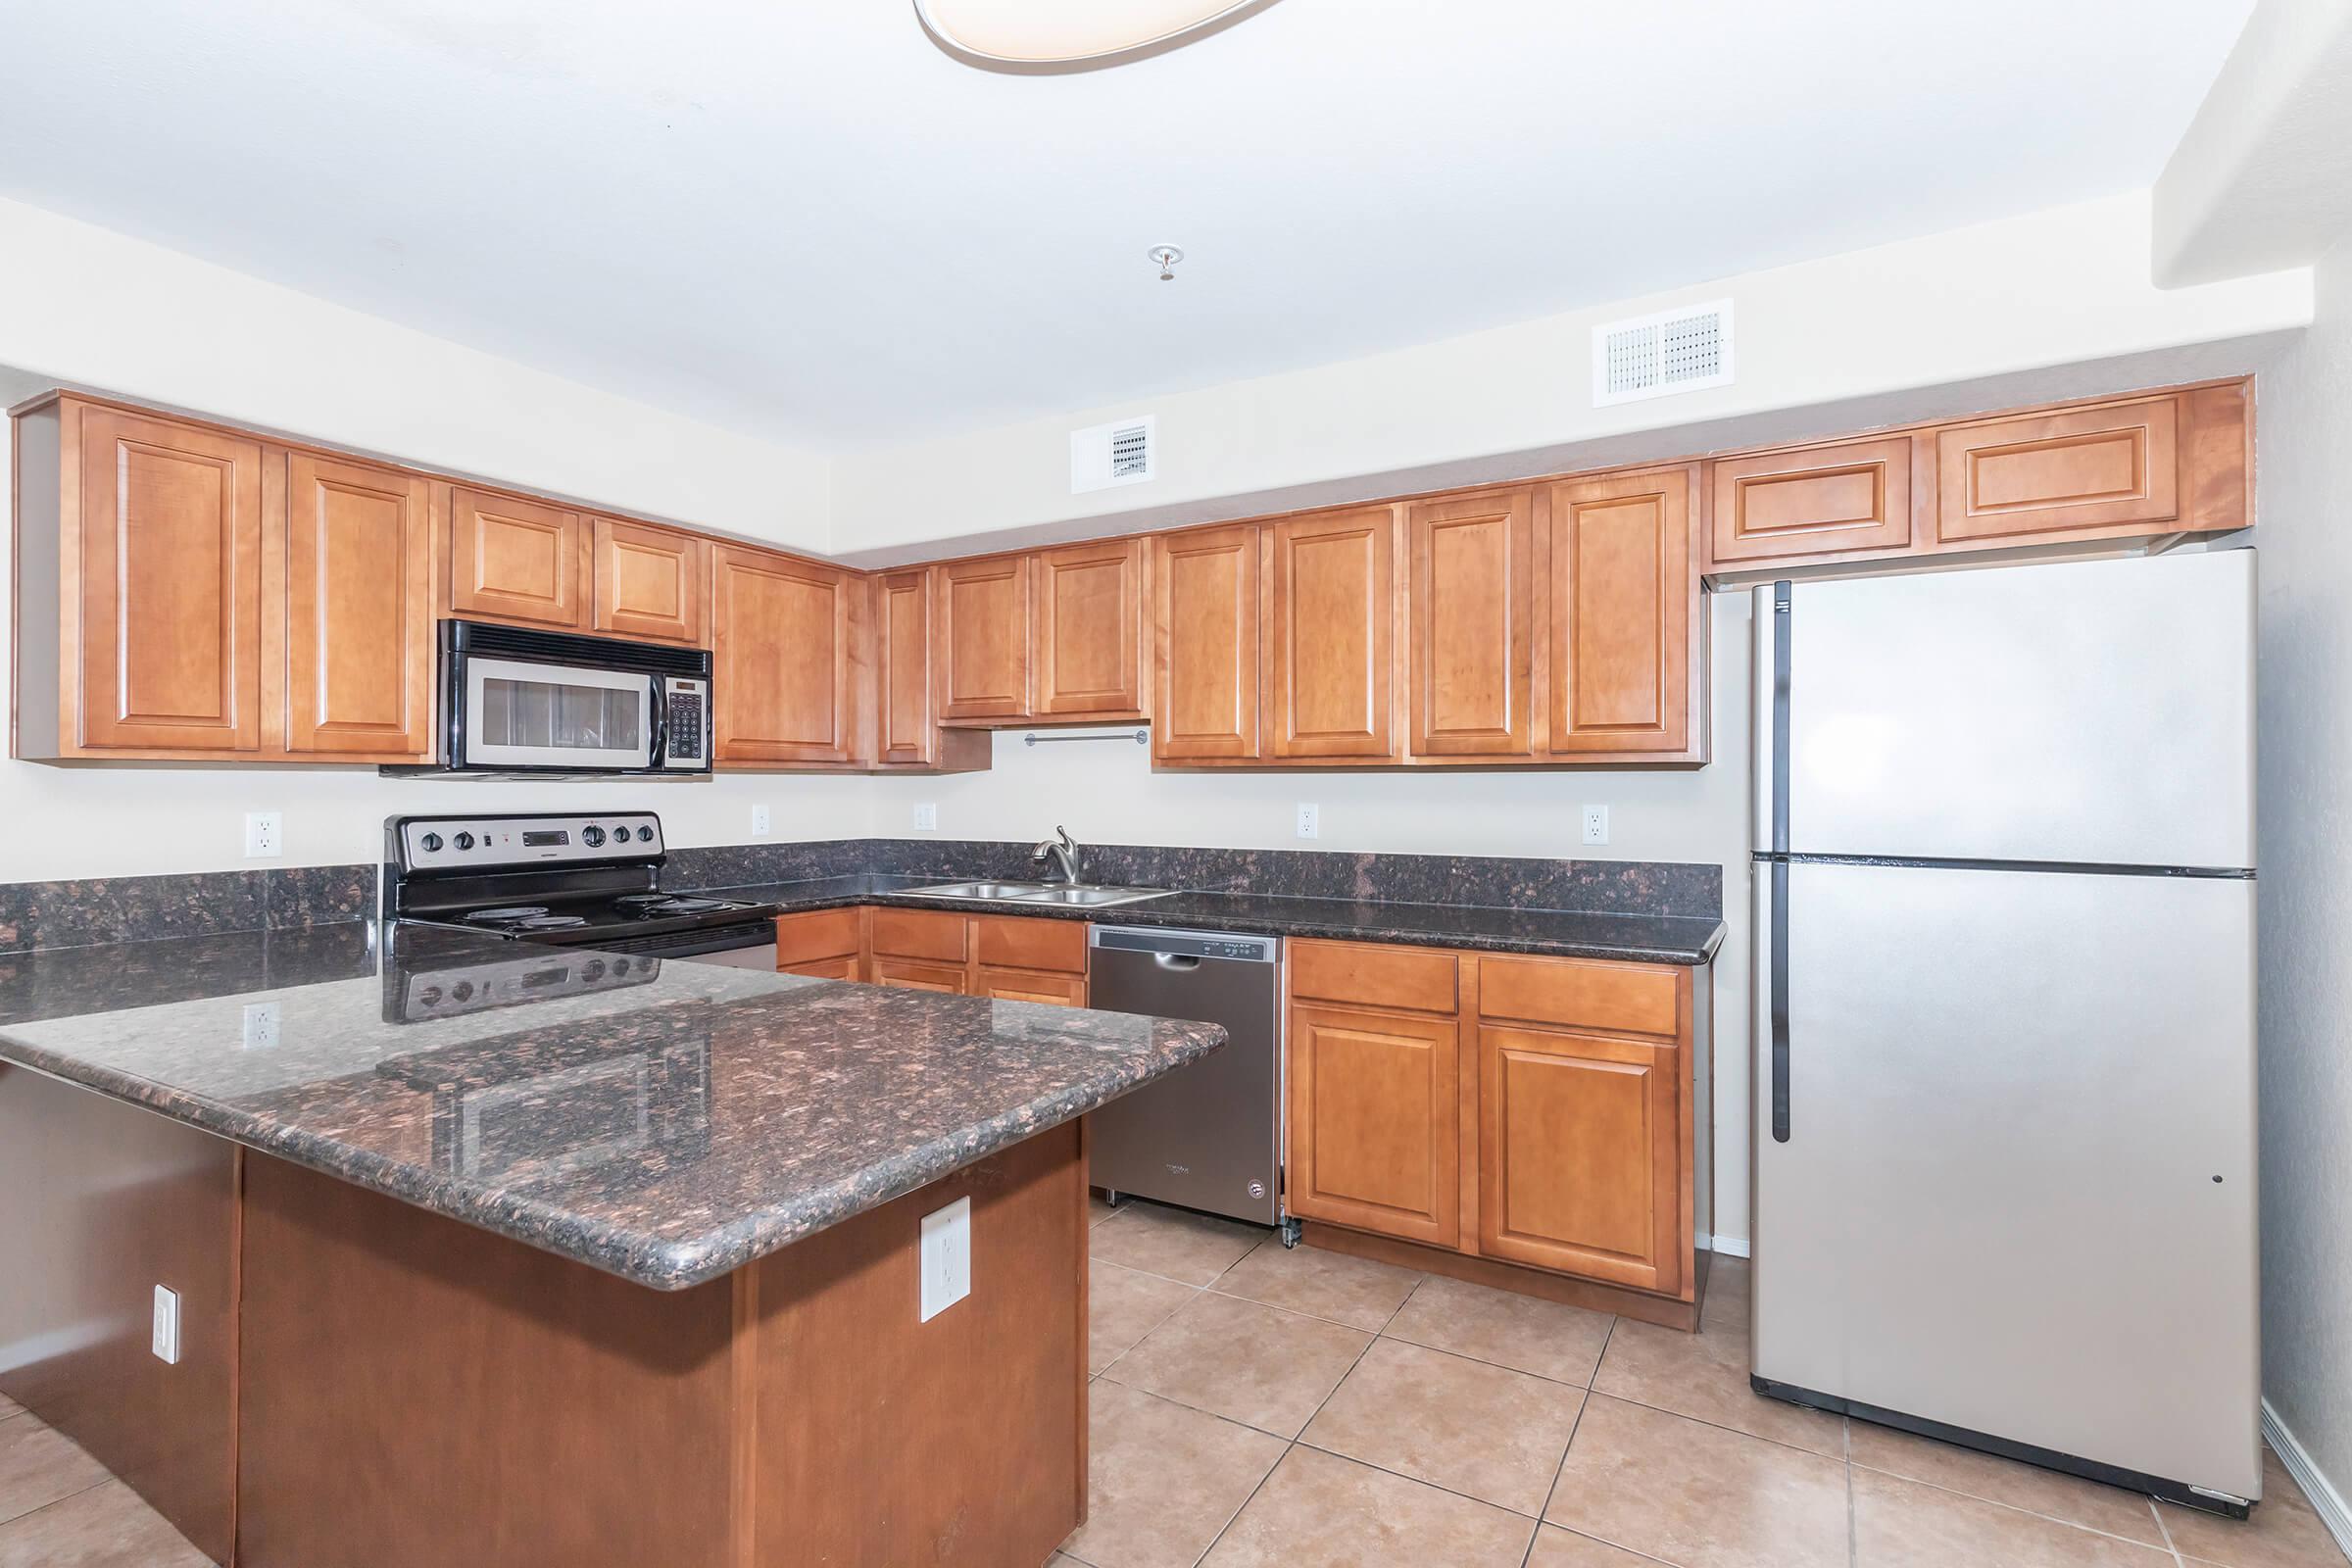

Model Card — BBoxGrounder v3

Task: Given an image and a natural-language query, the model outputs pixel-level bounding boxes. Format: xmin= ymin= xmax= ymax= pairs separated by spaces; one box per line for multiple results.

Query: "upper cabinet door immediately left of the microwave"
xmin=284 ymin=452 xmax=433 ymax=760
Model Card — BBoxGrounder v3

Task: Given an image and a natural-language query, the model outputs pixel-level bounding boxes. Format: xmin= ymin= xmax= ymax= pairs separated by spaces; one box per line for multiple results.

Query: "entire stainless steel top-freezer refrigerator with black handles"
xmin=1752 ymin=550 xmax=2263 ymax=1514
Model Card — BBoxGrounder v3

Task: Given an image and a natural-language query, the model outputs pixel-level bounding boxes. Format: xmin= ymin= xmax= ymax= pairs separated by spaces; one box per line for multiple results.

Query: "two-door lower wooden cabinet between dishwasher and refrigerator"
xmin=1284 ymin=941 xmax=1707 ymax=1302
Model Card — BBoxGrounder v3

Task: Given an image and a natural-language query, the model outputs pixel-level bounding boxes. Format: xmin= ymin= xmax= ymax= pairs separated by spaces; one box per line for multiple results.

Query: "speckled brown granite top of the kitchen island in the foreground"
xmin=0 ymin=921 xmax=1225 ymax=1291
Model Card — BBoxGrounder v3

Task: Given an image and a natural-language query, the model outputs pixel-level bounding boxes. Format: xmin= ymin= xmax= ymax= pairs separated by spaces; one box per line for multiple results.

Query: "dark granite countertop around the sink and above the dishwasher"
xmin=706 ymin=874 xmax=1724 ymax=964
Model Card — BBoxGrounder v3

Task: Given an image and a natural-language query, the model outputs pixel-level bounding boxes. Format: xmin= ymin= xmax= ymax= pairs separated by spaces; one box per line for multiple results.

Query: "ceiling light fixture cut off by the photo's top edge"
xmin=915 ymin=0 xmax=1275 ymax=73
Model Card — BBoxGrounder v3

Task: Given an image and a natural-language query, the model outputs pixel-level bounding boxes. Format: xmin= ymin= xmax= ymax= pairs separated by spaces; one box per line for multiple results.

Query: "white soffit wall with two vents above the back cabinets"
xmin=833 ymin=190 xmax=2310 ymax=553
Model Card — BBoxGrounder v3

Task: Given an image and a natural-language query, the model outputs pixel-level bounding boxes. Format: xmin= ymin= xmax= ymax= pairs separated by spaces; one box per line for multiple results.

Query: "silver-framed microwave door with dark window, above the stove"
xmin=449 ymin=656 xmax=659 ymax=773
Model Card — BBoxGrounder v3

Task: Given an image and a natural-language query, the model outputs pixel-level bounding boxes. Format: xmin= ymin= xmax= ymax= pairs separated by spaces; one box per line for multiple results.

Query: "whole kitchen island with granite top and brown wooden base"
xmin=0 ymin=926 xmax=1223 ymax=1568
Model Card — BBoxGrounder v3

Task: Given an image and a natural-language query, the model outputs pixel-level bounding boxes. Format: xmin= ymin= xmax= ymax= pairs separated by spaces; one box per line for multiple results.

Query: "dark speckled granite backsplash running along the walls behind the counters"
xmin=0 ymin=839 xmax=1724 ymax=953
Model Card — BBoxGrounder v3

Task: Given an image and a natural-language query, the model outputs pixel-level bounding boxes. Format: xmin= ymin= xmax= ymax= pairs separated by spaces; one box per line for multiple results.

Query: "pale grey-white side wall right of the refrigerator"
xmin=2258 ymin=240 xmax=2352 ymax=1491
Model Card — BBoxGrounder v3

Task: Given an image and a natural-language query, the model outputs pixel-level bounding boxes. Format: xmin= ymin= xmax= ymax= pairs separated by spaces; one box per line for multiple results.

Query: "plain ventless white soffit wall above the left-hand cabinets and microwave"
xmin=0 ymin=200 xmax=828 ymax=550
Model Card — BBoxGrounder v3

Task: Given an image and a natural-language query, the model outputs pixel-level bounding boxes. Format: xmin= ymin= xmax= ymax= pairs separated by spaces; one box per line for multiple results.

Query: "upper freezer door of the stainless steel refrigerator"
xmin=1754 ymin=550 xmax=2253 ymax=870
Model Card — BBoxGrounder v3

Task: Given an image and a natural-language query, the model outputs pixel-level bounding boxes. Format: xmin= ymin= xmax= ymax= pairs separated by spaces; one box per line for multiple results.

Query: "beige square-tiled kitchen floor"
xmin=0 ymin=1203 xmax=2345 ymax=1568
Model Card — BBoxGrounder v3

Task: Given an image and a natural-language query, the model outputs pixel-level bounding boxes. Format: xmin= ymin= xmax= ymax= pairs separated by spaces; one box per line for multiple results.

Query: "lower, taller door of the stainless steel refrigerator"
xmin=1752 ymin=862 xmax=2260 ymax=1497
